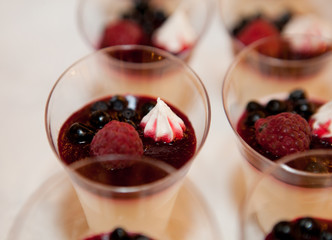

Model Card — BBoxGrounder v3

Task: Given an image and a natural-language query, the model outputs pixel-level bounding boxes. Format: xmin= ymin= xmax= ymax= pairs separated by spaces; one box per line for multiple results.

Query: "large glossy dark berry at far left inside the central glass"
xmin=68 ymin=123 xmax=95 ymax=144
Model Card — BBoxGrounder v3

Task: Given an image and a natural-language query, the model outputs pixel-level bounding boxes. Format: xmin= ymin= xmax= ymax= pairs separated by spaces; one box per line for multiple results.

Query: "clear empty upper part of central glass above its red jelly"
xmin=45 ymin=45 xmax=210 ymax=238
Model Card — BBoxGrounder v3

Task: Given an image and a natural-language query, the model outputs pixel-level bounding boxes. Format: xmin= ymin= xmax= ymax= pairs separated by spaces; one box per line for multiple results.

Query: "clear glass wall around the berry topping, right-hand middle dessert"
xmin=222 ymin=35 xmax=332 ymax=188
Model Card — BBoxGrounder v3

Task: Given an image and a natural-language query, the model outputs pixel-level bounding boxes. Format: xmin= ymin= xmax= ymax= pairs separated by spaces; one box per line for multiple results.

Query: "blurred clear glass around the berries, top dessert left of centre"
xmin=77 ymin=0 xmax=213 ymax=60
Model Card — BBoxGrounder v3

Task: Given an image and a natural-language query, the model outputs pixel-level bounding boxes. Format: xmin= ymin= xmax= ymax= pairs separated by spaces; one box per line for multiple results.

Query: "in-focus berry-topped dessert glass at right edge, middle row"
xmin=222 ymin=36 xmax=332 ymax=187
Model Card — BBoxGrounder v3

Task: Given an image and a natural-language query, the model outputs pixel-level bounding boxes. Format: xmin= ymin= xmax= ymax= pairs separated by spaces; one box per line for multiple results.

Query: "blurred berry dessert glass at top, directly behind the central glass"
xmin=78 ymin=0 xmax=213 ymax=60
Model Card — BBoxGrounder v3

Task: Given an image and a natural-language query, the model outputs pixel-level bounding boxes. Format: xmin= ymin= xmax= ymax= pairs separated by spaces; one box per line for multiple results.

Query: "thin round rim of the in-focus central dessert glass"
xmin=44 ymin=45 xmax=211 ymax=178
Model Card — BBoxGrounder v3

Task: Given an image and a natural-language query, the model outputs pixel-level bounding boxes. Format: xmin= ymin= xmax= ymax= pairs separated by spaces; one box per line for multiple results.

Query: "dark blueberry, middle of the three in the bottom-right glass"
xmin=295 ymin=217 xmax=320 ymax=239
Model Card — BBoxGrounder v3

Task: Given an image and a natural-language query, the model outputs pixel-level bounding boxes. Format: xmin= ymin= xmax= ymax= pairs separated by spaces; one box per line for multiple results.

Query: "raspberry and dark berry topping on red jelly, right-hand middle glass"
xmin=237 ymin=89 xmax=332 ymax=160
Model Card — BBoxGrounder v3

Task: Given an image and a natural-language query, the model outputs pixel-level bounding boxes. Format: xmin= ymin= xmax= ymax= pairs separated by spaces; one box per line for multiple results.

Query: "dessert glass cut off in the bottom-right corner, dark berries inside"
xmin=240 ymin=149 xmax=332 ymax=240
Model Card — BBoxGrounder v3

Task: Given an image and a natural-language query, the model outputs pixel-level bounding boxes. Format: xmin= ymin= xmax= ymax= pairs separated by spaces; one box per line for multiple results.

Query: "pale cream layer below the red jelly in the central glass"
xmin=74 ymin=181 xmax=182 ymax=239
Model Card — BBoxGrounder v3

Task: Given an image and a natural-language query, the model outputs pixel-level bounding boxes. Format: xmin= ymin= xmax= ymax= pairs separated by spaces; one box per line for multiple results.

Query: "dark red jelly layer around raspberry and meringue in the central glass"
xmin=58 ymin=95 xmax=196 ymax=169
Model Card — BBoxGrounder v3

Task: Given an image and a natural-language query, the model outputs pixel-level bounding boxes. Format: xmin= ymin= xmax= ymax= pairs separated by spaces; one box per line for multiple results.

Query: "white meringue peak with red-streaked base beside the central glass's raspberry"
xmin=140 ymin=98 xmax=186 ymax=143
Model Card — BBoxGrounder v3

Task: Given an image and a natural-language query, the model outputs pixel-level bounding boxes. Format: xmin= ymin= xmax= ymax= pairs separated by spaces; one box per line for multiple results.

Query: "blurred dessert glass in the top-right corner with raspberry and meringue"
xmin=219 ymin=0 xmax=332 ymax=55
